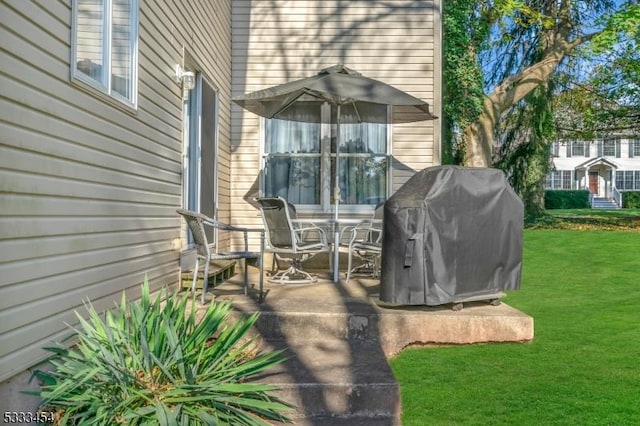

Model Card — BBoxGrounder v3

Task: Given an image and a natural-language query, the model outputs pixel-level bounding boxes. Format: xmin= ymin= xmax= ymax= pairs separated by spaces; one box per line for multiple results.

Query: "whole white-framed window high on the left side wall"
xmin=71 ymin=0 xmax=138 ymax=108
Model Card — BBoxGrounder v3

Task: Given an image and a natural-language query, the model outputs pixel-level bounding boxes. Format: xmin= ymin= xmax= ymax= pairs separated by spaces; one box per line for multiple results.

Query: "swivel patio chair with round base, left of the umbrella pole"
xmin=256 ymin=197 xmax=329 ymax=284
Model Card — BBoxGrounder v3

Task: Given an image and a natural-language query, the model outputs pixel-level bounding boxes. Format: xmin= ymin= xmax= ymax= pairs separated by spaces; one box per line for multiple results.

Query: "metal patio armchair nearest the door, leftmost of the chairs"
xmin=177 ymin=209 xmax=265 ymax=303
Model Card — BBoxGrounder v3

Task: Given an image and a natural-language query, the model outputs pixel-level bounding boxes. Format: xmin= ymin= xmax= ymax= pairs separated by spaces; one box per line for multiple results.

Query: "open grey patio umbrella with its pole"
xmin=233 ymin=64 xmax=436 ymax=282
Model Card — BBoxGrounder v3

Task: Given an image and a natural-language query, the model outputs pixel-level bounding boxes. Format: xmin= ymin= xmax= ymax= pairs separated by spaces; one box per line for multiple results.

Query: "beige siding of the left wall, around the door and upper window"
xmin=0 ymin=0 xmax=231 ymax=381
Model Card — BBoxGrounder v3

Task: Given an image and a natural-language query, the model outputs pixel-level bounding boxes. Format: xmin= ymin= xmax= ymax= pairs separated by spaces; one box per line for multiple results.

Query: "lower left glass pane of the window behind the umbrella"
xmin=264 ymin=155 xmax=320 ymax=204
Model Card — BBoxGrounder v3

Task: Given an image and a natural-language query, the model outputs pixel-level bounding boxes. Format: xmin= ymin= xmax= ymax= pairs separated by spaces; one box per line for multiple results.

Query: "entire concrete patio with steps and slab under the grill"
xmin=215 ymin=278 xmax=533 ymax=426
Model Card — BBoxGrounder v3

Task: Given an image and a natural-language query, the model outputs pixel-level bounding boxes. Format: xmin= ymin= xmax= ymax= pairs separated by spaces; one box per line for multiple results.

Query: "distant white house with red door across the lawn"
xmin=545 ymin=137 xmax=640 ymax=207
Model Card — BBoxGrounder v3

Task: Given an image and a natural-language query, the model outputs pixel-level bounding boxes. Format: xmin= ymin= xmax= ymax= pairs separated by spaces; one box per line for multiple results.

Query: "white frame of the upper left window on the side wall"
xmin=70 ymin=0 xmax=139 ymax=109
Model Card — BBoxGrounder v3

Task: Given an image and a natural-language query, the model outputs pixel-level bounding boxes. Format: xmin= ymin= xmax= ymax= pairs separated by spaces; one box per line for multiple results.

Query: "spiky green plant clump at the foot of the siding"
xmin=36 ymin=280 xmax=292 ymax=425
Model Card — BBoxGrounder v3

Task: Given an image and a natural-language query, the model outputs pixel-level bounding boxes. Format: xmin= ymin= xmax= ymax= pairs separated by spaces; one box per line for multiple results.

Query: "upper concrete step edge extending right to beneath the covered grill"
xmin=236 ymin=300 xmax=533 ymax=358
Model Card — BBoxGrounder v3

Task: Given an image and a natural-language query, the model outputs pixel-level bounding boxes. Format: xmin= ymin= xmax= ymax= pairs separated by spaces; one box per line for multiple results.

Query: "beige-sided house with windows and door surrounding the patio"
xmin=0 ymin=0 xmax=442 ymax=411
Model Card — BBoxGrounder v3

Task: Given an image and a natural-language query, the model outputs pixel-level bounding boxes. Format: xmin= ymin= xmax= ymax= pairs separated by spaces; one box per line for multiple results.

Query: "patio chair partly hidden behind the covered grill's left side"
xmin=345 ymin=203 xmax=384 ymax=283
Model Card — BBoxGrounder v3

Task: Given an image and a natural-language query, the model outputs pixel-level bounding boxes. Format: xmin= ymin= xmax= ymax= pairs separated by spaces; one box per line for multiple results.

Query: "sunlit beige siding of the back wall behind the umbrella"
xmin=231 ymin=0 xmax=441 ymax=235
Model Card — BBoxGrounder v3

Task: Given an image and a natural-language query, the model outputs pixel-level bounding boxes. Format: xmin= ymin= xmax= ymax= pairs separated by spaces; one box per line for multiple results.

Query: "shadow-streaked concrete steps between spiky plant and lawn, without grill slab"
xmin=236 ymin=301 xmax=401 ymax=426
